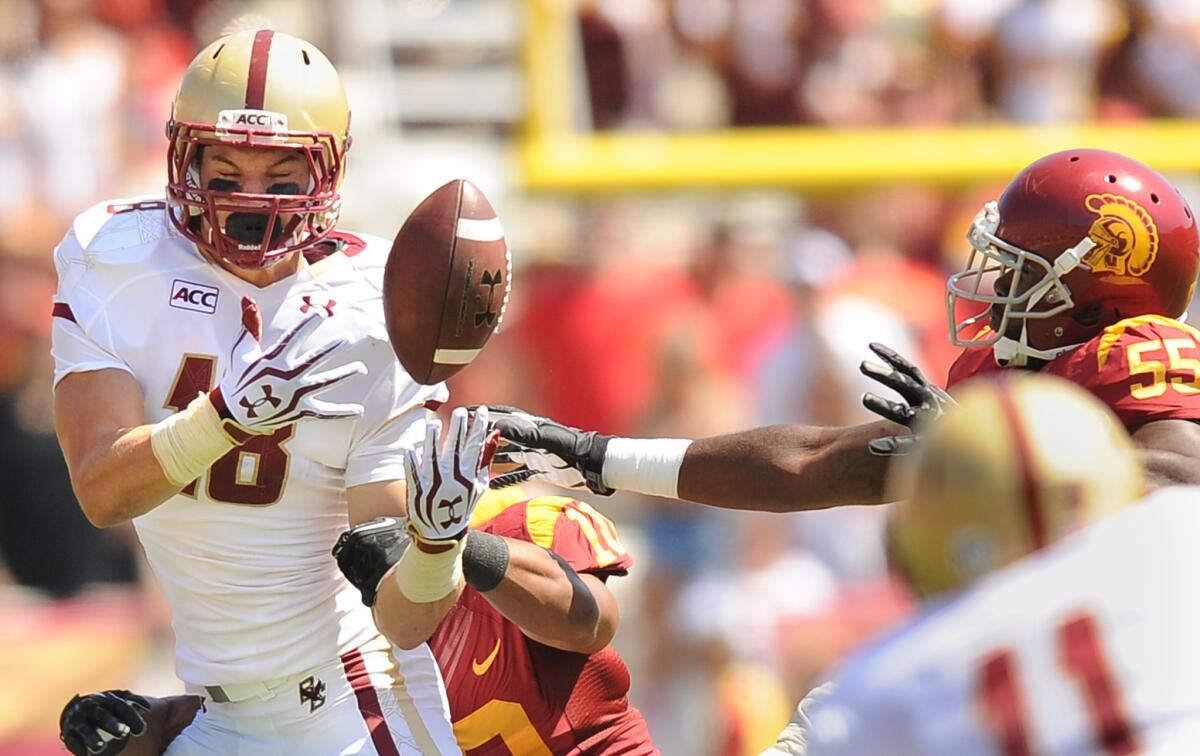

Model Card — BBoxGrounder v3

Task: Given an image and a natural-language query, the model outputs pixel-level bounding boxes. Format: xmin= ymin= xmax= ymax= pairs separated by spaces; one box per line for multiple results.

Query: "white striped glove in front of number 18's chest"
xmin=209 ymin=296 xmax=367 ymax=433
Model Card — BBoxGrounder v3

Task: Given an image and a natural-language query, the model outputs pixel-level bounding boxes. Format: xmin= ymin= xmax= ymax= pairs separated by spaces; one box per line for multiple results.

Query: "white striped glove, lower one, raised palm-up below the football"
xmin=404 ymin=407 xmax=497 ymax=544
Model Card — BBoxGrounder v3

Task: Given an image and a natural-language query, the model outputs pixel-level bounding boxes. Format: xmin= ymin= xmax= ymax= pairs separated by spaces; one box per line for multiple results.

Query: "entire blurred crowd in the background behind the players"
xmin=0 ymin=0 xmax=1200 ymax=755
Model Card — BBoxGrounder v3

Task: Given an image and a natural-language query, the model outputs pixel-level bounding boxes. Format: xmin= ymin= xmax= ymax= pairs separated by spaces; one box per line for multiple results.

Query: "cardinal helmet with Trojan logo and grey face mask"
xmin=946 ymin=150 xmax=1200 ymax=367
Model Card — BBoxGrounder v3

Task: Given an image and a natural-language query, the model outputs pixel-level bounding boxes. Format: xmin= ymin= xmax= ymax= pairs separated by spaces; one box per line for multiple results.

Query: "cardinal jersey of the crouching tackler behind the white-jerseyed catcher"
xmin=430 ymin=497 xmax=658 ymax=756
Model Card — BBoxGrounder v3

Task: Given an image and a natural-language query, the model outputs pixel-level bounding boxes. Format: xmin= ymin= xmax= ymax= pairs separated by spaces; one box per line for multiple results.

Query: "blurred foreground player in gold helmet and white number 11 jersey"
xmin=767 ymin=374 xmax=1200 ymax=756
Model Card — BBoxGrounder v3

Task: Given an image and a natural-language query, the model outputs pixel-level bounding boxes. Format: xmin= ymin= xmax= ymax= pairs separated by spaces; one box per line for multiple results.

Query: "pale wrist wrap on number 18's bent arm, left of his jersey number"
xmin=150 ymin=394 xmax=235 ymax=487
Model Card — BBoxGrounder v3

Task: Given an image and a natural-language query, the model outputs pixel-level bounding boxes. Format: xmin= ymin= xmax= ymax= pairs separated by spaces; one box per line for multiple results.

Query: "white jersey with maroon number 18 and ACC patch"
xmin=53 ymin=198 xmax=446 ymax=685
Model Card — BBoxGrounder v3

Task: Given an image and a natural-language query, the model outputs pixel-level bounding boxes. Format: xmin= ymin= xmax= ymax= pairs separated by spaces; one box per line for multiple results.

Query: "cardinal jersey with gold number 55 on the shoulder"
xmin=947 ymin=316 xmax=1200 ymax=431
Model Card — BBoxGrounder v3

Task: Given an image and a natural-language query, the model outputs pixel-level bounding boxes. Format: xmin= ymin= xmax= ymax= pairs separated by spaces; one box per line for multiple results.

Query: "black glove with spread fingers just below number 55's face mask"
xmin=859 ymin=343 xmax=958 ymax=457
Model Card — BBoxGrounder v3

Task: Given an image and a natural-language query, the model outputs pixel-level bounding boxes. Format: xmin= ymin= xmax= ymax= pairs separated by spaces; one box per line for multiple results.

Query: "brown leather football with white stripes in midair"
xmin=383 ymin=179 xmax=512 ymax=385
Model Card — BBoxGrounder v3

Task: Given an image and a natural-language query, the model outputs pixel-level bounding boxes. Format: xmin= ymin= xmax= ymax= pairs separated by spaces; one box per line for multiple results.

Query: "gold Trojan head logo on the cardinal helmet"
xmin=1084 ymin=194 xmax=1158 ymax=277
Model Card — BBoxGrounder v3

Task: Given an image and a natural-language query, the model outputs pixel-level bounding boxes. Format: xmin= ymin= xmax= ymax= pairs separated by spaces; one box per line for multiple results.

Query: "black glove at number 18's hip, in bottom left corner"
xmin=59 ymin=690 xmax=150 ymax=756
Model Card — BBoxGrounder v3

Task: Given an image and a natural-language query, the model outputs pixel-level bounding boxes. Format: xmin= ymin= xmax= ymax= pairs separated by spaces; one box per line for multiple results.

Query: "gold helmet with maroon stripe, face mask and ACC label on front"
xmin=167 ymin=29 xmax=350 ymax=268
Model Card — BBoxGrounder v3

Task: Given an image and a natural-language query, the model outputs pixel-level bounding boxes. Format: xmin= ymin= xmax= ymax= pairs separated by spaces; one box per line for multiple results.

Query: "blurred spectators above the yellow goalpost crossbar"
xmin=582 ymin=0 xmax=1200 ymax=130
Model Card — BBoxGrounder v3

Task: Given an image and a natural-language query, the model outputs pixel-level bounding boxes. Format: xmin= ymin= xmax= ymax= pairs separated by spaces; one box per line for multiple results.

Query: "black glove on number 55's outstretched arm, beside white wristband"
xmin=487 ymin=404 xmax=613 ymax=496
